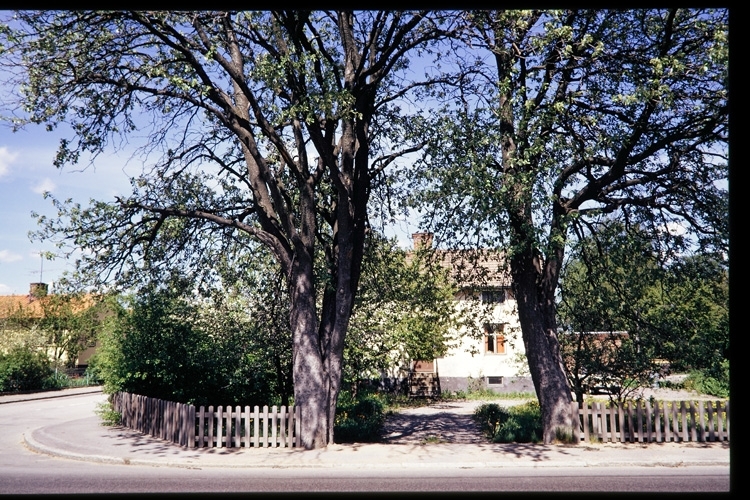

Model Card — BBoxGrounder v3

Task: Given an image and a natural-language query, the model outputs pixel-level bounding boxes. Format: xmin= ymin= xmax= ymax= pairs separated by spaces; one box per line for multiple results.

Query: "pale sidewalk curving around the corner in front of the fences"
xmin=11 ymin=389 xmax=729 ymax=470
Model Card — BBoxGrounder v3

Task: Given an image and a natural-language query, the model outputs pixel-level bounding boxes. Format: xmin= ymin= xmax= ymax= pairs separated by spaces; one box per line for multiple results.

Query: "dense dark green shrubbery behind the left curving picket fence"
xmin=95 ymin=289 xmax=278 ymax=405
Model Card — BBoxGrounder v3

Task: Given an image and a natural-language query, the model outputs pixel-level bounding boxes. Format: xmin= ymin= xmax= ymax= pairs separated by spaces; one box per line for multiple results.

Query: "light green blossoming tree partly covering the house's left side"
xmin=344 ymin=231 xmax=456 ymax=392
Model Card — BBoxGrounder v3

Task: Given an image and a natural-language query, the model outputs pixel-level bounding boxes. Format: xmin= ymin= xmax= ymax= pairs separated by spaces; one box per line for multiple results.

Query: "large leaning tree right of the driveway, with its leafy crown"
xmin=414 ymin=9 xmax=728 ymax=442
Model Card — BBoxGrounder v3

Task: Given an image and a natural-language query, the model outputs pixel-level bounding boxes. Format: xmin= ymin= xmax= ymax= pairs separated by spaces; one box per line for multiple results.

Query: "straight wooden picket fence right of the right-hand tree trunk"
xmin=571 ymin=400 xmax=729 ymax=443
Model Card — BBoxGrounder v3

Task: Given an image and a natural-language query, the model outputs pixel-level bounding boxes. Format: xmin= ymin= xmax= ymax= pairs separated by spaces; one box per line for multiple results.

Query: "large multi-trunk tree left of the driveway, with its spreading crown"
xmin=0 ymin=11 xmax=456 ymax=448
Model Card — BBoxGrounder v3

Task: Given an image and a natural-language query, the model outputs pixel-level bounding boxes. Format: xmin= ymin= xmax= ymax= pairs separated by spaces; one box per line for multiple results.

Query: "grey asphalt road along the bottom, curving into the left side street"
xmin=0 ymin=394 xmax=730 ymax=496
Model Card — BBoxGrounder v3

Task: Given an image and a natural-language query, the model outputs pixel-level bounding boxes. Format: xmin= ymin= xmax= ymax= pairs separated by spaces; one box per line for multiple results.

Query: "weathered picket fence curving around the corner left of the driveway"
xmin=113 ymin=392 xmax=301 ymax=448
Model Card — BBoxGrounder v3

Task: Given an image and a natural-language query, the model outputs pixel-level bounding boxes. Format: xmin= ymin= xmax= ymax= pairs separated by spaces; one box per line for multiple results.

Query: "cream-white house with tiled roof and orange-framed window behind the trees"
xmin=409 ymin=233 xmax=534 ymax=394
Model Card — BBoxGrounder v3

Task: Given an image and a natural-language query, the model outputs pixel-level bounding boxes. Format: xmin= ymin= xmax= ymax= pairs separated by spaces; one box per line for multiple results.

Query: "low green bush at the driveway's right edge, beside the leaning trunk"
xmin=474 ymin=401 xmax=542 ymax=443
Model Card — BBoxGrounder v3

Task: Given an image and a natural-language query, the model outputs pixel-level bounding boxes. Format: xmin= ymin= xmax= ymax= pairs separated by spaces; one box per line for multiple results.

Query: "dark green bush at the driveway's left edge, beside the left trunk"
xmin=333 ymin=391 xmax=385 ymax=443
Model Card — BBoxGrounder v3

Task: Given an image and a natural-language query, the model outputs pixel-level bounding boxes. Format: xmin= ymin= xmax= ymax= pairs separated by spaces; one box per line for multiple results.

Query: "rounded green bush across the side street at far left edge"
xmin=0 ymin=347 xmax=61 ymax=392
